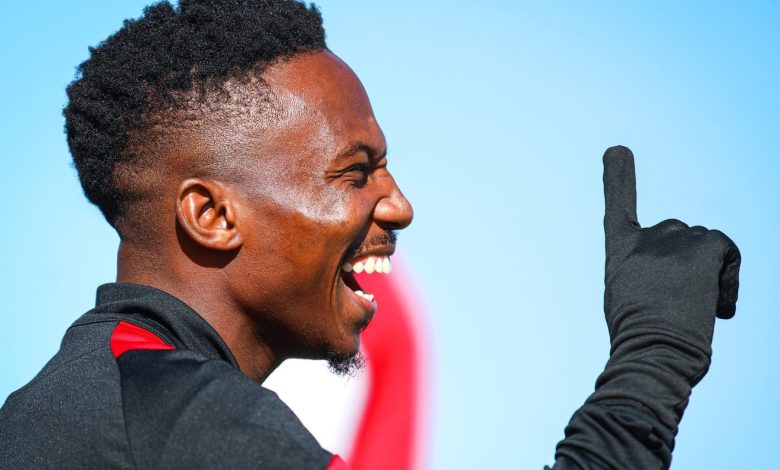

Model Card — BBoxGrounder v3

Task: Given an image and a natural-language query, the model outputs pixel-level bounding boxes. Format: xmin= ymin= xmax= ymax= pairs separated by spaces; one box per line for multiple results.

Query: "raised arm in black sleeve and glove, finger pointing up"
xmin=553 ymin=147 xmax=740 ymax=470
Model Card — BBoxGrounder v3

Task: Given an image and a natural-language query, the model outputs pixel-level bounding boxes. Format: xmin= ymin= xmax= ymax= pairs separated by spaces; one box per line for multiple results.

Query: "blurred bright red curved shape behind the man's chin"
xmin=349 ymin=256 xmax=428 ymax=470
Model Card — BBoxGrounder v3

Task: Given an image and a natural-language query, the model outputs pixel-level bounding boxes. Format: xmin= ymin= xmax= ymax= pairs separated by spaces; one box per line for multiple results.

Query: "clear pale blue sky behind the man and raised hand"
xmin=0 ymin=0 xmax=780 ymax=469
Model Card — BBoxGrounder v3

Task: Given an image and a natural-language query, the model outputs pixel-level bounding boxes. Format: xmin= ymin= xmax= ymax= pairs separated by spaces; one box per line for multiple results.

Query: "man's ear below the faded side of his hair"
xmin=176 ymin=178 xmax=243 ymax=251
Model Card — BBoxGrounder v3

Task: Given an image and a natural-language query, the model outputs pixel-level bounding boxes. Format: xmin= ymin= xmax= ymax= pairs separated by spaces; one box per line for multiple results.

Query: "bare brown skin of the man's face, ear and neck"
xmin=117 ymin=50 xmax=412 ymax=382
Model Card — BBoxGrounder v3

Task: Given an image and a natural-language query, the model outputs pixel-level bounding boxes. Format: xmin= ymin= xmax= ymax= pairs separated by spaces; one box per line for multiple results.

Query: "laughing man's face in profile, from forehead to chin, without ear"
xmin=221 ymin=51 xmax=412 ymax=368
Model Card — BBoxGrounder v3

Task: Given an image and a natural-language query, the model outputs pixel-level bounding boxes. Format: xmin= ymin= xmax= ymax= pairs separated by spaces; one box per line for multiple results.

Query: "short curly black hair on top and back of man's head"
xmin=63 ymin=0 xmax=327 ymax=227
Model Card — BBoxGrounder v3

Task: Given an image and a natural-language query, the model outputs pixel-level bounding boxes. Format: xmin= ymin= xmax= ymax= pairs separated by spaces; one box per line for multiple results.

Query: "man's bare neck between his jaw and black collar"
xmin=116 ymin=241 xmax=283 ymax=383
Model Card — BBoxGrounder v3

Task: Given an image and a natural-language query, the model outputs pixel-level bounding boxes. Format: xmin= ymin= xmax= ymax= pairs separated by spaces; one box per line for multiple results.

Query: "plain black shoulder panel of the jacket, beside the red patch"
xmin=117 ymin=350 xmax=332 ymax=469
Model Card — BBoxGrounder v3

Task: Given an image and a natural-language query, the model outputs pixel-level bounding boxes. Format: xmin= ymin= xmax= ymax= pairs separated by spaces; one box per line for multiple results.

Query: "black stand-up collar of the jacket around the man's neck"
xmin=83 ymin=283 xmax=238 ymax=367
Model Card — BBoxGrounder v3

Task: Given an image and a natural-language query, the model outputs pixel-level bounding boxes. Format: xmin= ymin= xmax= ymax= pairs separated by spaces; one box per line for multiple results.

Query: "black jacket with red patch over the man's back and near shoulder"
xmin=0 ymin=284 xmax=348 ymax=469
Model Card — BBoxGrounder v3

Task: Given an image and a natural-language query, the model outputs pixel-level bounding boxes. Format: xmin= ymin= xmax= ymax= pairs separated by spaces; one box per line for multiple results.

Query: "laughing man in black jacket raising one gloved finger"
xmin=0 ymin=0 xmax=739 ymax=469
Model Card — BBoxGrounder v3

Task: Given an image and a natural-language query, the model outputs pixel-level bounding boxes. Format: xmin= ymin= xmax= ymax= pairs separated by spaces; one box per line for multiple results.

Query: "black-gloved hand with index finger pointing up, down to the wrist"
xmin=587 ymin=147 xmax=740 ymax=433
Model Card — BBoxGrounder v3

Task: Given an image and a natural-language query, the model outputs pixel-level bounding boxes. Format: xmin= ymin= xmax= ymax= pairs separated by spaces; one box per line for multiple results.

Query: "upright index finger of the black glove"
xmin=604 ymin=145 xmax=639 ymax=253
